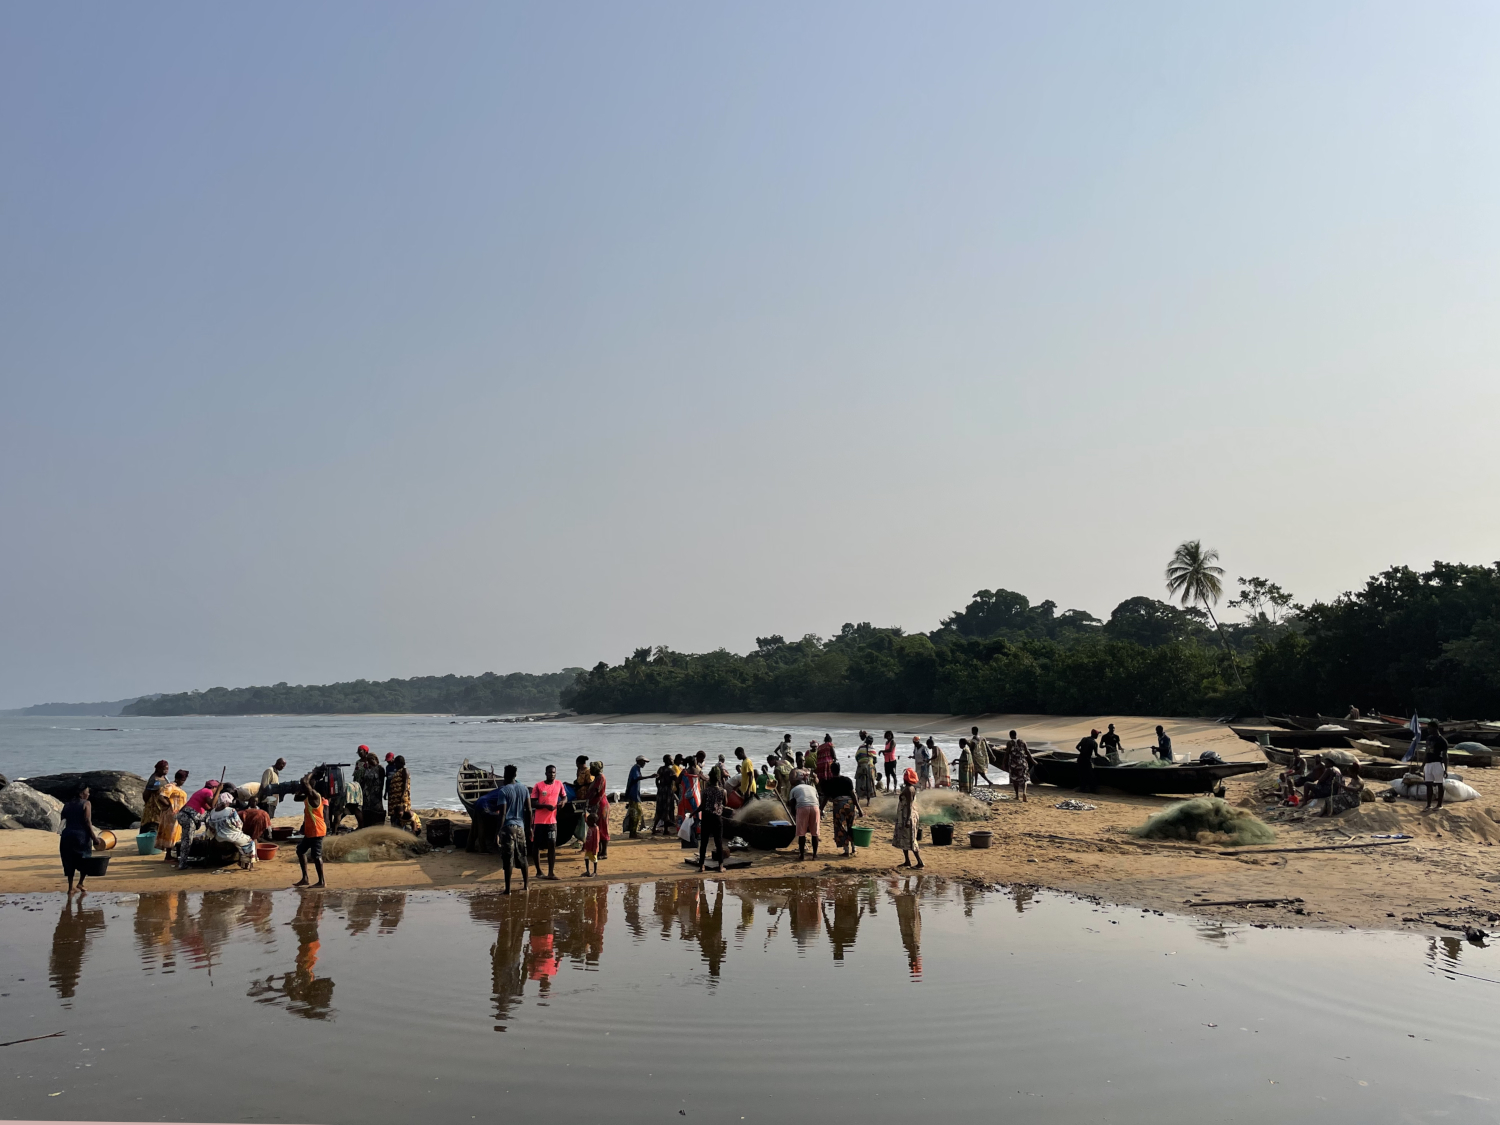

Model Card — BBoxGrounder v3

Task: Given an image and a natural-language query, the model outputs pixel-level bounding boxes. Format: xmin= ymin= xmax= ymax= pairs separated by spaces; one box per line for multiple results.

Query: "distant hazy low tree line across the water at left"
xmin=122 ymin=668 xmax=582 ymax=716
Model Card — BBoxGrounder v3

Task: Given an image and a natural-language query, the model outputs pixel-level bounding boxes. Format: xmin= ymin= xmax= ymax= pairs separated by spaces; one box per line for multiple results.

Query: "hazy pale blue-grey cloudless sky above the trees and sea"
xmin=0 ymin=0 xmax=1500 ymax=707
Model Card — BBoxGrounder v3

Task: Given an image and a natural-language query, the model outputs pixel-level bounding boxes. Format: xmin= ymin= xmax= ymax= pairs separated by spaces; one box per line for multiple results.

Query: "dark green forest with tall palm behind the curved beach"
xmin=561 ymin=564 xmax=1500 ymax=719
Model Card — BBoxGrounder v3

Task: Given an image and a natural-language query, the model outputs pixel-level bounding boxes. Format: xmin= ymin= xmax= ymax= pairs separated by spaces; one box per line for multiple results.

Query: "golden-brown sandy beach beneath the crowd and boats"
xmin=0 ymin=714 xmax=1500 ymax=935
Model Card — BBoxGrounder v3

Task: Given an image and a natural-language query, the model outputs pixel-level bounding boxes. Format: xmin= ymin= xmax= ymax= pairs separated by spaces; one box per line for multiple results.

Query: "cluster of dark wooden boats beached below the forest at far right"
xmin=1230 ymin=716 xmax=1500 ymax=782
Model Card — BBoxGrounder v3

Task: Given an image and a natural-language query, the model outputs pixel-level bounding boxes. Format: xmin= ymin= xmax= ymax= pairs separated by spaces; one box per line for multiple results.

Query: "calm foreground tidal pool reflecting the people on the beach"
xmin=0 ymin=876 xmax=1500 ymax=1125
